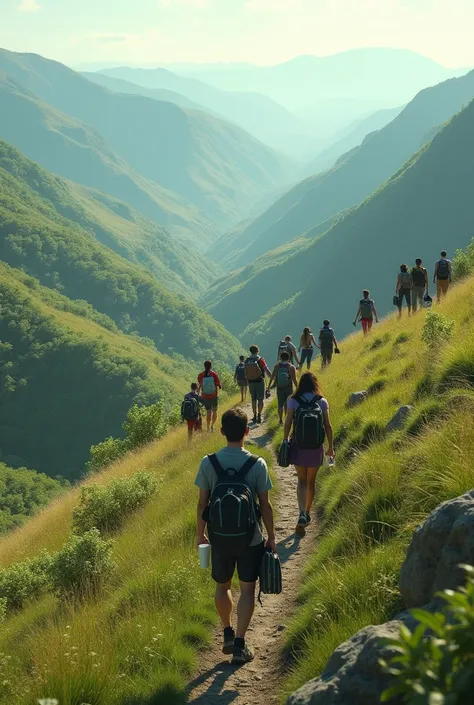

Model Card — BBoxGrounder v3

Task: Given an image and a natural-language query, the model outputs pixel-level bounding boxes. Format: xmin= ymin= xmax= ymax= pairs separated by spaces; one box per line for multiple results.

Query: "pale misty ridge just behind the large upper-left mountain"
xmin=98 ymin=66 xmax=318 ymax=154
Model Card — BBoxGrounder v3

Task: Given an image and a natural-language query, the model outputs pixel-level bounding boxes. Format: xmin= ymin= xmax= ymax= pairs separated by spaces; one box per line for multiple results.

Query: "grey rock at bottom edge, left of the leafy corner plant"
xmin=287 ymin=612 xmax=416 ymax=705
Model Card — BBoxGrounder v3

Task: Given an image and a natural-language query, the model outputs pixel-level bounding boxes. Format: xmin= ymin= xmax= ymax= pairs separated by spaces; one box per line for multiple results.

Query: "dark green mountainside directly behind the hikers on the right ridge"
xmin=209 ymin=97 xmax=474 ymax=345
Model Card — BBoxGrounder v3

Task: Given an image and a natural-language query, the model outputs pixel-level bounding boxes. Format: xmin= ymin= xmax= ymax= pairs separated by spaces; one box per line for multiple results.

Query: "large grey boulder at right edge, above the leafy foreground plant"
xmin=400 ymin=490 xmax=474 ymax=608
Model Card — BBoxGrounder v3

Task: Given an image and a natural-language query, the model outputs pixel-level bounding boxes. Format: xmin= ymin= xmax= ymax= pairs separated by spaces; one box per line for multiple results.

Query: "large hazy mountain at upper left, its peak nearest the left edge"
xmin=0 ymin=51 xmax=290 ymax=225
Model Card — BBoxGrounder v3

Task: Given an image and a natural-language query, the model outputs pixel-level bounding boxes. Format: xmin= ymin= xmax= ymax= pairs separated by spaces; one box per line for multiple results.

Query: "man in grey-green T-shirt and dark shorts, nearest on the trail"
xmin=195 ymin=409 xmax=276 ymax=664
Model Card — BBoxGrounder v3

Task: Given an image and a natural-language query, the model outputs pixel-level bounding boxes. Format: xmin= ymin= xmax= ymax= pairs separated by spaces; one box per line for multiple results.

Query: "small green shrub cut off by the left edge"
xmin=0 ymin=551 xmax=53 ymax=612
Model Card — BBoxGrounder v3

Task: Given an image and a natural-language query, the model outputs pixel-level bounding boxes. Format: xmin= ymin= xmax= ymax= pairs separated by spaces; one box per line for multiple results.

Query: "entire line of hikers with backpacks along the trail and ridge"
xmin=189 ymin=251 xmax=451 ymax=665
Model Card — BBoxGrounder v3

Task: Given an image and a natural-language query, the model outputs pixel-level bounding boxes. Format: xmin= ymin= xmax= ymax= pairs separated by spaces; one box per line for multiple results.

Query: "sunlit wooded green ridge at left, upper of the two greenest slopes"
xmin=0 ymin=143 xmax=240 ymax=361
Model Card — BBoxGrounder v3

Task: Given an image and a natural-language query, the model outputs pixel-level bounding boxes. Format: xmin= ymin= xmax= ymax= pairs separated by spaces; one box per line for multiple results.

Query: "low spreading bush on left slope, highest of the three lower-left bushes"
xmin=73 ymin=472 xmax=158 ymax=534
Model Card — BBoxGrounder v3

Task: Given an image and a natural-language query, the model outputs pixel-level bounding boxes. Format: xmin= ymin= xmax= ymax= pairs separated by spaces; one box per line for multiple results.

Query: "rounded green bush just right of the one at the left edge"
xmin=51 ymin=529 xmax=115 ymax=599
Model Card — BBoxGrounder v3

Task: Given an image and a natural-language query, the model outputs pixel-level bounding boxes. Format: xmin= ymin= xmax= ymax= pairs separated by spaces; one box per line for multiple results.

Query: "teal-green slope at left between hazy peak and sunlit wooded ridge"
xmin=0 ymin=69 xmax=217 ymax=249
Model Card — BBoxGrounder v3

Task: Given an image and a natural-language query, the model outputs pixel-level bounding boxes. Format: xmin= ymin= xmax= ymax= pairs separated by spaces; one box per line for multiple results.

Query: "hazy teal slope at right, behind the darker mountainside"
xmin=212 ymin=71 xmax=474 ymax=267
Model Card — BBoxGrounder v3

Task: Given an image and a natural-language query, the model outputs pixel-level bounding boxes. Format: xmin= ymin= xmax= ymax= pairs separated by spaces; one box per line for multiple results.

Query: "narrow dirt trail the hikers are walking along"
xmin=187 ymin=408 xmax=316 ymax=705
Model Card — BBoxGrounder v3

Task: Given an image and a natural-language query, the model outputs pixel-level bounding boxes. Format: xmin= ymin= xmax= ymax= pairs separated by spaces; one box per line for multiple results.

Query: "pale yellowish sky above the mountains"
xmin=0 ymin=0 xmax=474 ymax=67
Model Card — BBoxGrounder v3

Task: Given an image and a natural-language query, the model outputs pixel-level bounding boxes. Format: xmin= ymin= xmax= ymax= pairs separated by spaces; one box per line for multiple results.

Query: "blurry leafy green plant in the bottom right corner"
xmin=381 ymin=566 xmax=474 ymax=705
